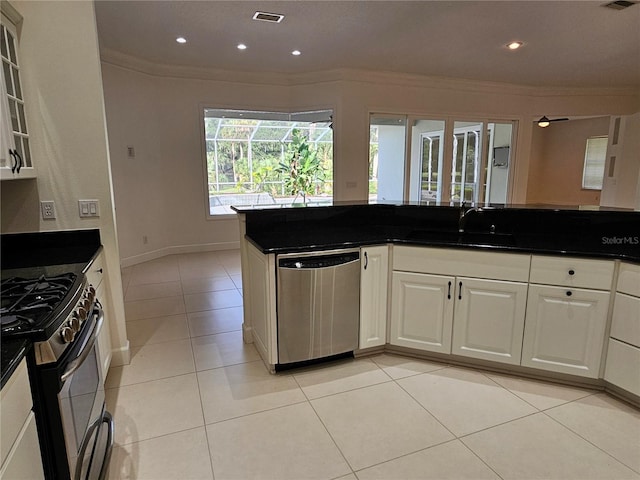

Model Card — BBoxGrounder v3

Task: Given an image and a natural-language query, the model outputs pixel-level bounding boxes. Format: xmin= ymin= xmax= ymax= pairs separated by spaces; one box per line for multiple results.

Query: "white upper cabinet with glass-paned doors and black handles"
xmin=0 ymin=11 xmax=35 ymax=180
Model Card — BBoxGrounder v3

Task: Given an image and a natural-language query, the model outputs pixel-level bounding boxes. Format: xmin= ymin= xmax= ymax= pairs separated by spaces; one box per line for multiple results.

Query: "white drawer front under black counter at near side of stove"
xmin=0 ymin=360 xmax=32 ymax=463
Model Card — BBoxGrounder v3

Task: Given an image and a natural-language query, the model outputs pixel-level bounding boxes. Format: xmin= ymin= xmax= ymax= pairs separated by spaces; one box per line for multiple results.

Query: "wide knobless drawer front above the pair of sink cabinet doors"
xmin=393 ymin=247 xmax=530 ymax=282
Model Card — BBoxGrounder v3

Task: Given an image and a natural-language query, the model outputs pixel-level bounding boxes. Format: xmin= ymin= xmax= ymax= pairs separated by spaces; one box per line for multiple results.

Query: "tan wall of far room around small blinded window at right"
xmin=527 ymin=117 xmax=609 ymax=205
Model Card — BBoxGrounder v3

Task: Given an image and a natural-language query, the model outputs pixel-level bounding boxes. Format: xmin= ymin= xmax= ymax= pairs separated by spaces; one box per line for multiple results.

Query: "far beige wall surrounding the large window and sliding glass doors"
xmin=102 ymin=60 xmax=638 ymax=264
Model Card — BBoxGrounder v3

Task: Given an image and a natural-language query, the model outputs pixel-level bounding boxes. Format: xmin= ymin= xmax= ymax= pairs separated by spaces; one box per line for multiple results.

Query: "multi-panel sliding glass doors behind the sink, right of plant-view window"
xmin=369 ymin=114 xmax=515 ymax=204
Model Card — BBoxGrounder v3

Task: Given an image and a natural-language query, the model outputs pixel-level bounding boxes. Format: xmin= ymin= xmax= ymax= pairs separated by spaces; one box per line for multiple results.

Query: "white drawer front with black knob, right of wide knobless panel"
xmin=529 ymin=255 xmax=614 ymax=290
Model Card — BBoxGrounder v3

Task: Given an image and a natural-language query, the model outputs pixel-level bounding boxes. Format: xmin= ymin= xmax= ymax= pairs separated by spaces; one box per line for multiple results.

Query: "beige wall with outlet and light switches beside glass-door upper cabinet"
xmin=1 ymin=1 xmax=128 ymax=364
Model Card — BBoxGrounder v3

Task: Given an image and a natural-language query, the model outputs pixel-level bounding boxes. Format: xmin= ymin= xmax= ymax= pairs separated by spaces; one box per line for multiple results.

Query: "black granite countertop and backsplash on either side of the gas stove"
xmin=0 ymin=230 xmax=102 ymax=386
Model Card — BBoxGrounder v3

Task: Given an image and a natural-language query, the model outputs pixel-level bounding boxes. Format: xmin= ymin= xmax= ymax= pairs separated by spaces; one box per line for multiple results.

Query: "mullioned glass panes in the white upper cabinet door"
xmin=0 ymin=9 xmax=32 ymax=172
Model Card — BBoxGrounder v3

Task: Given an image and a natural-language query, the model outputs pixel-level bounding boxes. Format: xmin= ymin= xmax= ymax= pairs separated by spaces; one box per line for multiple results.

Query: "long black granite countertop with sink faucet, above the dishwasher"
xmin=238 ymin=204 xmax=640 ymax=263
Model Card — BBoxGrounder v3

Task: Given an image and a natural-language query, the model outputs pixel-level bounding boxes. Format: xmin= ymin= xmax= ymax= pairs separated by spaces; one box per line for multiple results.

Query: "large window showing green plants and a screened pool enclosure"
xmin=204 ymin=109 xmax=333 ymax=215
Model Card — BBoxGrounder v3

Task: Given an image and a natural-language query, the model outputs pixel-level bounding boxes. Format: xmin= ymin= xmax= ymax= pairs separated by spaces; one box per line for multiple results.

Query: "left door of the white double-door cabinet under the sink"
xmin=390 ymin=272 xmax=455 ymax=353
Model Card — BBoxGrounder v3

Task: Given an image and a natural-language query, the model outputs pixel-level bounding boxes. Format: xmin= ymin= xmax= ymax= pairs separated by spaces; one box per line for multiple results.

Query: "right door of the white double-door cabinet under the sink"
xmin=451 ymin=277 xmax=527 ymax=365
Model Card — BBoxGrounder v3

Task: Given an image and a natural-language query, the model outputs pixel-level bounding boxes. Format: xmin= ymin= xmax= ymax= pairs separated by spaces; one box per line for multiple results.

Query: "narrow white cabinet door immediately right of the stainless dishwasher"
xmin=359 ymin=245 xmax=389 ymax=348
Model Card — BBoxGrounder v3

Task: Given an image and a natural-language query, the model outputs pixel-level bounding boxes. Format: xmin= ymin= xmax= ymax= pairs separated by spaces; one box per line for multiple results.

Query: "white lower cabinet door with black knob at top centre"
xmin=522 ymin=285 xmax=610 ymax=378
